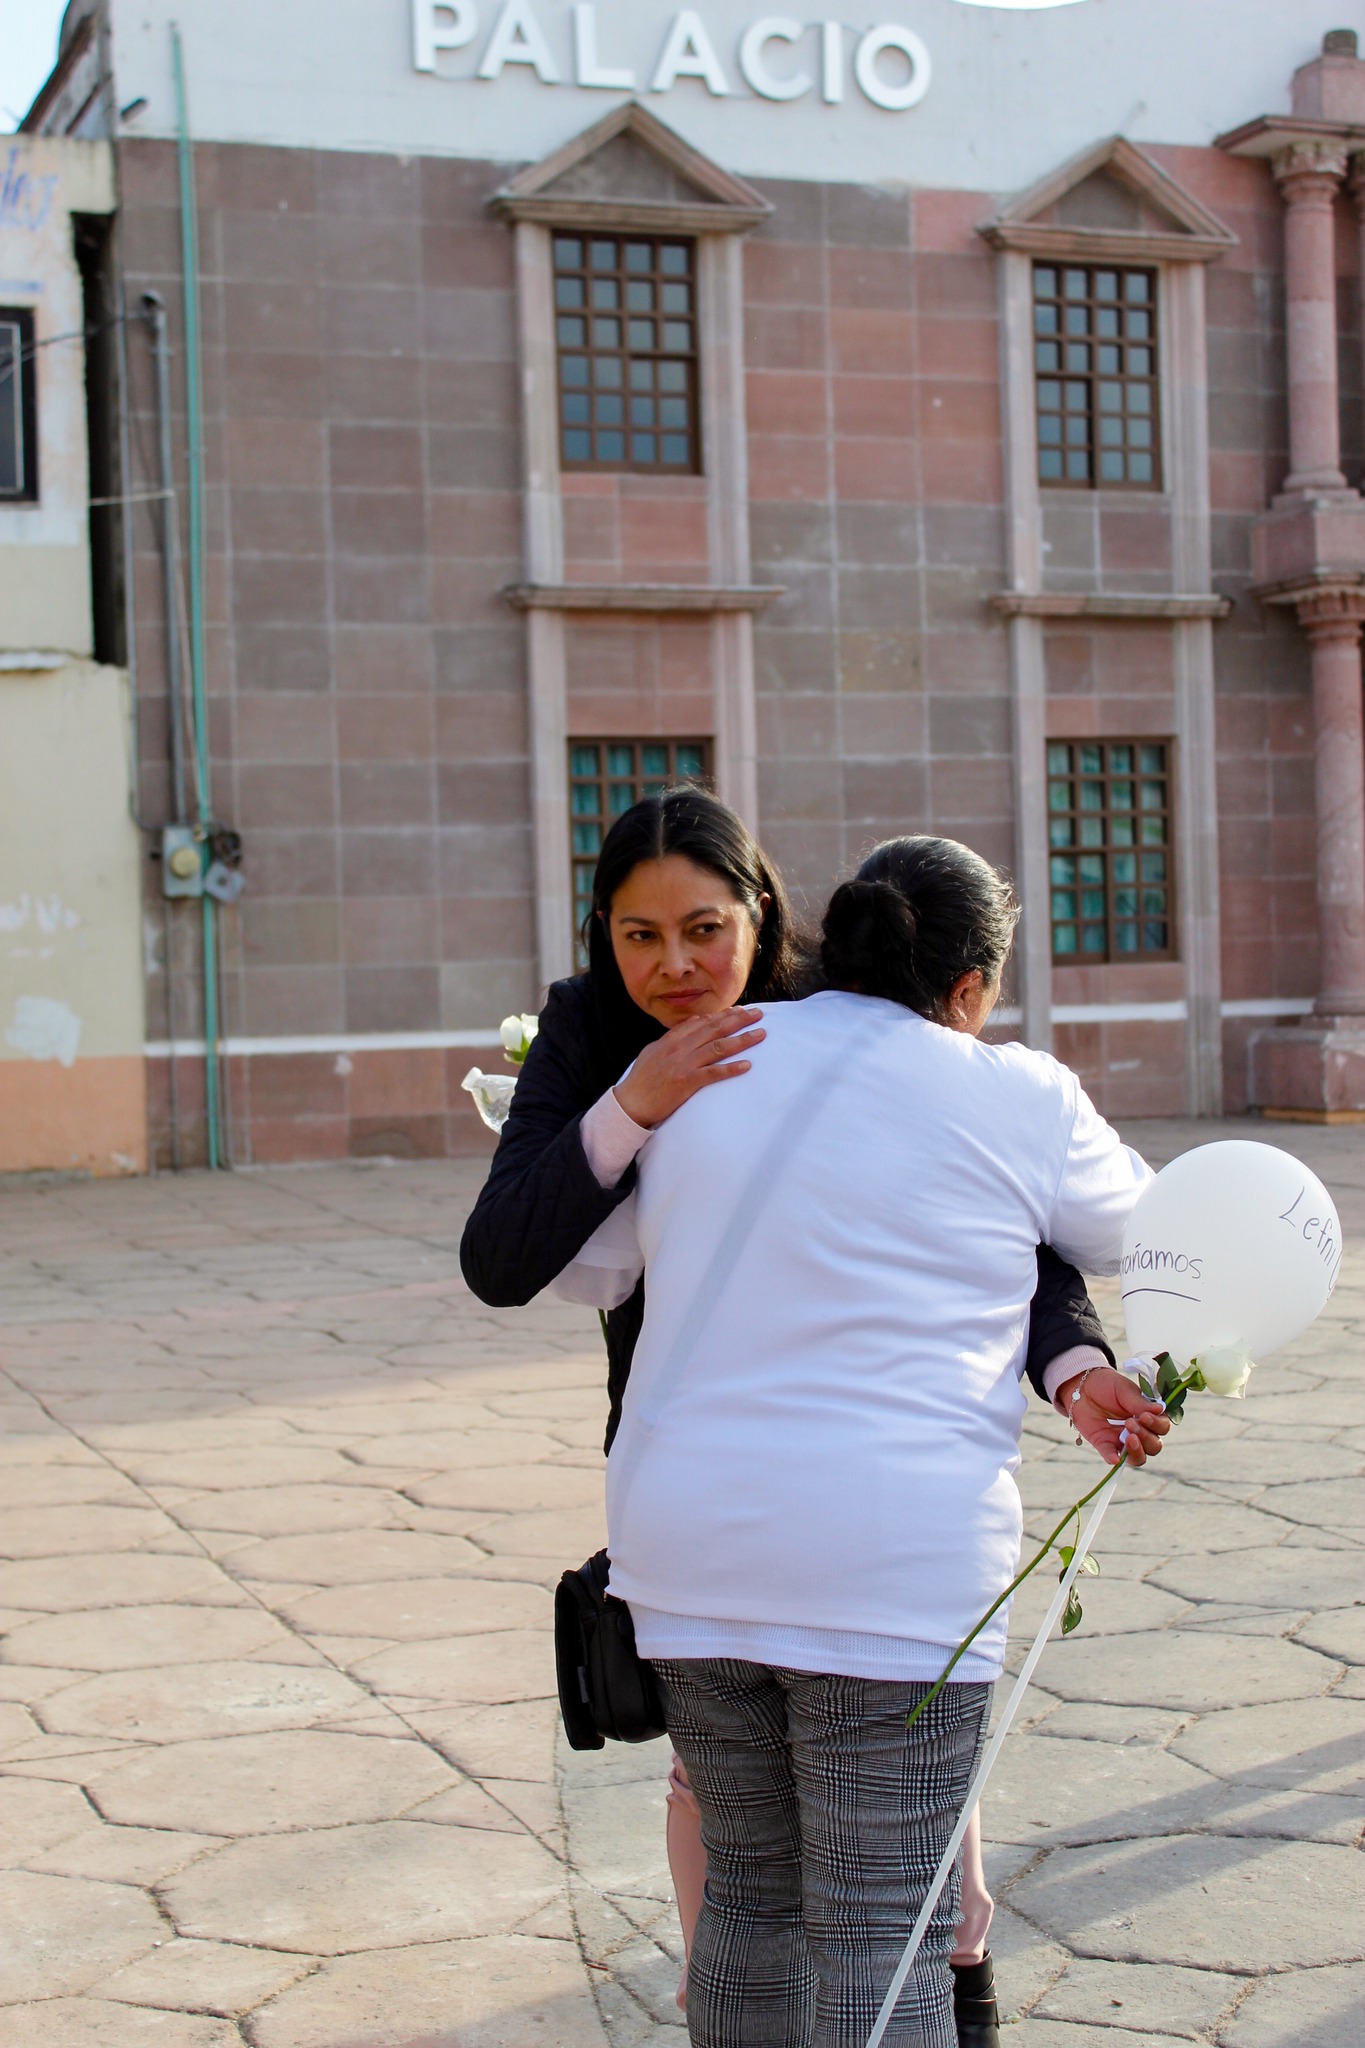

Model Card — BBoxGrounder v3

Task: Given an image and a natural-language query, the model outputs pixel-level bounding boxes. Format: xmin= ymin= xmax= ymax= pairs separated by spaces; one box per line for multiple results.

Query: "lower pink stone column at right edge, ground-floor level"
xmin=1297 ymin=590 xmax=1365 ymax=1016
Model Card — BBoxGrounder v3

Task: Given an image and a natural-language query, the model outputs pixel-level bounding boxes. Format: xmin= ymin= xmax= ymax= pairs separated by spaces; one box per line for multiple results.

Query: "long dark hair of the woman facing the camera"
xmin=583 ymin=782 xmax=810 ymax=1036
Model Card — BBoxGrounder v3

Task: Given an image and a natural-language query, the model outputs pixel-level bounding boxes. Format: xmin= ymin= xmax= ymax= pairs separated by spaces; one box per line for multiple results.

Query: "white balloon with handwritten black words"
xmin=1119 ymin=1139 xmax=1342 ymax=1366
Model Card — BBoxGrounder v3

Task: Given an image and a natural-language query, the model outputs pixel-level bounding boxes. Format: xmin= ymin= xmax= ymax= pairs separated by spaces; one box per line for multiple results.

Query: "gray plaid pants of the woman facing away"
xmin=655 ymin=1659 xmax=990 ymax=2048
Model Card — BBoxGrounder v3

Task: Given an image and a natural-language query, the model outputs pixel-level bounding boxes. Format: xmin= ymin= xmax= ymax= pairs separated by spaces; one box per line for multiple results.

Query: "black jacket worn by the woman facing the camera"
xmin=460 ymin=975 xmax=1113 ymax=1450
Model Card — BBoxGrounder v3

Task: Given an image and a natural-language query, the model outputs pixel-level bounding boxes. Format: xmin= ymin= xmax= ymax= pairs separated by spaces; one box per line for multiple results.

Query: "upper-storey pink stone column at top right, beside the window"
xmin=1273 ymin=139 xmax=1347 ymax=494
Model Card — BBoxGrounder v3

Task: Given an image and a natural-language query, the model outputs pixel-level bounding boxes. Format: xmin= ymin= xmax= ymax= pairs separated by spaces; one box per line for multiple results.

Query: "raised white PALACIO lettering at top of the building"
xmin=411 ymin=0 xmax=933 ymax=113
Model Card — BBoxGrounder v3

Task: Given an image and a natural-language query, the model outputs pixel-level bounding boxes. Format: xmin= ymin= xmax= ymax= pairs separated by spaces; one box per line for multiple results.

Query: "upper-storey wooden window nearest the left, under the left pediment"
xmin=551 ymin=227 xmax=702 ymax=477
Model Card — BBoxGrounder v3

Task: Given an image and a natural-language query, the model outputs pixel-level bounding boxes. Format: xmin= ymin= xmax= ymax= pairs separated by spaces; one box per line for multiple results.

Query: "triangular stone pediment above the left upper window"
xmin=493 ymin=100 xmax=772 ymax=233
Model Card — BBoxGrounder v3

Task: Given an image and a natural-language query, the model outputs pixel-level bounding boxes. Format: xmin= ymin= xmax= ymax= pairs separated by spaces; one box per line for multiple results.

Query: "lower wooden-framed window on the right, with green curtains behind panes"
xmin=1048 ymin=735 xmax=1179 ymax=967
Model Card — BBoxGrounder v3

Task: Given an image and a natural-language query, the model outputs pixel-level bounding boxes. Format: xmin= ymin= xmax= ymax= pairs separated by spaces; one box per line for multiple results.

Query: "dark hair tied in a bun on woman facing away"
xmin=821 ymin=838 xmax=1019 ymax=1022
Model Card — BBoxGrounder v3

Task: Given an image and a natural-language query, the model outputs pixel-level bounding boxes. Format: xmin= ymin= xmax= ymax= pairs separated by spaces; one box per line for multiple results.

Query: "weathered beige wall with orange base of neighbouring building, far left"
xmin=0 ymin=137 xmax=147 ymax=1174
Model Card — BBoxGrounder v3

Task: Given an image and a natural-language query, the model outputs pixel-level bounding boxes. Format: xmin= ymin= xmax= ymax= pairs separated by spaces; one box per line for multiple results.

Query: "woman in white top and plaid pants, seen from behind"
xmin=581 ymin=838 xmax=1164 ymax=2048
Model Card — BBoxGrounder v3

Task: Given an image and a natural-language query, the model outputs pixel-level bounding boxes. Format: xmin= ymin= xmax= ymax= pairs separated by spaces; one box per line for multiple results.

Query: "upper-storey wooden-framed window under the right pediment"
xmin=1031 ymin=258 xmax=1164 ymax=492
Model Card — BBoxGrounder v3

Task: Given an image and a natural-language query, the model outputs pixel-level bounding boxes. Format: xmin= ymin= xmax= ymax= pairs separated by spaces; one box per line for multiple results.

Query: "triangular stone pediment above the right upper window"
xmin=980 ymin=135 xmax=1236 ymax=262
